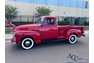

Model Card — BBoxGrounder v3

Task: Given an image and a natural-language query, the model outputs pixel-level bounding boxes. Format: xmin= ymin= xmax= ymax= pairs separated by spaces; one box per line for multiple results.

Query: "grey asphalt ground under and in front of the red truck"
xmin=5 ymin=36 xmax=89 ymax=63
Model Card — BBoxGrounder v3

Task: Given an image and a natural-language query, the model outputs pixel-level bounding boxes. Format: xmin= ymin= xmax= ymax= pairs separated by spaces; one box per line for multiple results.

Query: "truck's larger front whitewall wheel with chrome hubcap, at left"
xmin=21 ymin=38 xmax=34 ymax=50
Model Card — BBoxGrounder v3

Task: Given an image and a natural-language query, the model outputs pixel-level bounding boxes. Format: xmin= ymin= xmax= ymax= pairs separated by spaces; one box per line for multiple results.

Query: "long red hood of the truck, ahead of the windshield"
xmin=14 ymin=24 xmax=41 ymax=31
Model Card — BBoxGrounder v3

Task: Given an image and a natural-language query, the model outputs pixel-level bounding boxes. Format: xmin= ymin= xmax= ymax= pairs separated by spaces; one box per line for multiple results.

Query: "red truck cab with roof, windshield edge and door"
xmin=38 ymin=16 xmax=58 ymax=40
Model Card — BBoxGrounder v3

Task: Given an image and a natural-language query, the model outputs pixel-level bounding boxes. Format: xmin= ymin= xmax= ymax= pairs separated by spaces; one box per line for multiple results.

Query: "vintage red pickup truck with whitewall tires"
xmin=11 ymin=16 xmax=84 ymax=49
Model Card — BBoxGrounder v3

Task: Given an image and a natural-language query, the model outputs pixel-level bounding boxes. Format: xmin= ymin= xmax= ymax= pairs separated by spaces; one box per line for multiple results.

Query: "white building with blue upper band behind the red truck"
xmin=6 ymin=0 xmax=89 ymax=24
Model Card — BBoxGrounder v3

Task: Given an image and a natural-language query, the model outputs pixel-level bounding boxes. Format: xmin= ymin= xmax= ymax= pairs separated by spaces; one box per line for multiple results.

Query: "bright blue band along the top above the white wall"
xmin=12 ymin=0 xmax=89 ymax=8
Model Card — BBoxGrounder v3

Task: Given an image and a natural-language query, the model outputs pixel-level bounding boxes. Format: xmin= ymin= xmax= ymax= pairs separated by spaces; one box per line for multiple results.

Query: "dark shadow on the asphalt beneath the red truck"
xmin=11 ymin=40 xmax=84 ymax=52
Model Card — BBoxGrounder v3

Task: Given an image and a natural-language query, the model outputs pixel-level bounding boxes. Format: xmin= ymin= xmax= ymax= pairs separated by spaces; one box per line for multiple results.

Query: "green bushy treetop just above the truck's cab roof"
xmin=35 ymin=7 xmax=53 ymax=16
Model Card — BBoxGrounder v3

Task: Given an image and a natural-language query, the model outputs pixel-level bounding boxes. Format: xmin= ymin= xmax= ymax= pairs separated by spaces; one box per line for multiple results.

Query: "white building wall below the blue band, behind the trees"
xmin=6 ymin=1 xmax=89 ymax=17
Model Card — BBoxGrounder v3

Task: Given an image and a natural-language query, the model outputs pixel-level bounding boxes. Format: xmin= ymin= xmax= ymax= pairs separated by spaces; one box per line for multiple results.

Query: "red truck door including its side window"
xmin=41 ymin=18 xmax=58 ymax=40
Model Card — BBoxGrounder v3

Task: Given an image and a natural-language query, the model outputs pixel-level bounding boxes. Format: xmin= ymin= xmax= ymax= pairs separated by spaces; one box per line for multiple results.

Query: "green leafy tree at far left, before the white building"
xmin=5 ymin=5 xmax=18 ymax=21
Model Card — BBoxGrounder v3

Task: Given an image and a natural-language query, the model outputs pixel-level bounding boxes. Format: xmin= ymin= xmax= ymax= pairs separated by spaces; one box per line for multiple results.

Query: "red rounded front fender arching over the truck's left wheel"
xmin=15 ymin=31 xmax=41 ymax=44
